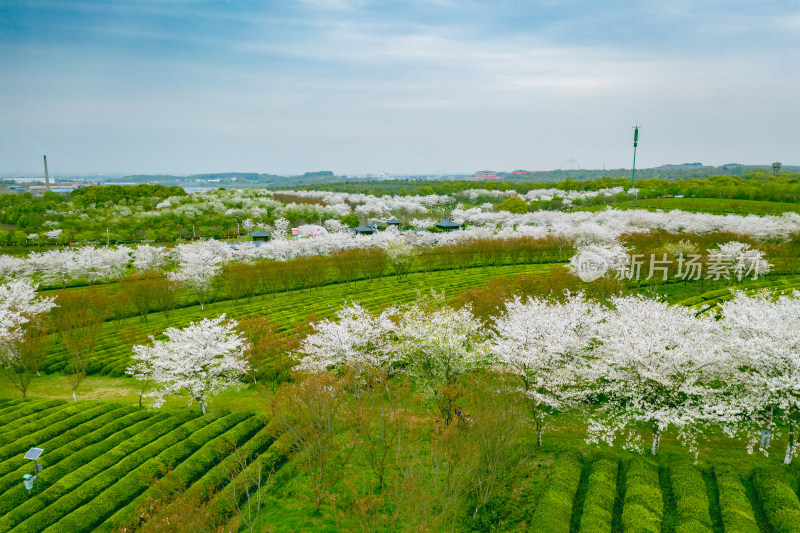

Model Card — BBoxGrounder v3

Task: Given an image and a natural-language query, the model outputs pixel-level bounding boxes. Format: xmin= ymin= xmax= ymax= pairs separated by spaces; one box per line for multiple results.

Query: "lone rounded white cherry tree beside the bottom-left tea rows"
xmin=126 ymin=314 xmax=249 ymax=414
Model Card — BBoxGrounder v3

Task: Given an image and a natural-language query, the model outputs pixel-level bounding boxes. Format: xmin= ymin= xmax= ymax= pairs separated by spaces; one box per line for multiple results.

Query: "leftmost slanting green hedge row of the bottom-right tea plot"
xmin=531 ymin=448 xmax=581 ymax=533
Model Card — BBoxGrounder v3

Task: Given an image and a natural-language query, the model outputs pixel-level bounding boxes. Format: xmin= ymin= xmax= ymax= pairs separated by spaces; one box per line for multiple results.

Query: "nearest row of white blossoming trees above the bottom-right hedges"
xmin=298 ymin=291 xmax=800 ymax=464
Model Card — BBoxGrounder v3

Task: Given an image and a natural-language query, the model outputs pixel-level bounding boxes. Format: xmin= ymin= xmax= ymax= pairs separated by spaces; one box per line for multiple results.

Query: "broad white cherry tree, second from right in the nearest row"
xmin=587 ymin=296 xmax=725 ymax=454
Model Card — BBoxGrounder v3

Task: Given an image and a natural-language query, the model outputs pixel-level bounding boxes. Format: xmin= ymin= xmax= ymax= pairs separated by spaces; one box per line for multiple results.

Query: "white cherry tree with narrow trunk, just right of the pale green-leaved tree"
xmin=492 ymin=293 xmax=604 ymax=446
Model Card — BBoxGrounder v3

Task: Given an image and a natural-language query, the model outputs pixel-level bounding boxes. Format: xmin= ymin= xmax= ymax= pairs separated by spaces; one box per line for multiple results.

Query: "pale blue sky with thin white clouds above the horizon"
xmin=0 ymin=0 xmax=800 ymax=175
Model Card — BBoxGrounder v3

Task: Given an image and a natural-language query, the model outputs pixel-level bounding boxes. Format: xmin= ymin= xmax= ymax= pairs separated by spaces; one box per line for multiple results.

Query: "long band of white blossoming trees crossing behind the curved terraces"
xmin=0 ymin=205 xmax=800 ymax=285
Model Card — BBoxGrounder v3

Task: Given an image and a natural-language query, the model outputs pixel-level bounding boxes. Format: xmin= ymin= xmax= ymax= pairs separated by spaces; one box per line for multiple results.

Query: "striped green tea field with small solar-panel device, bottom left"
xmin=0 ymin=400 xmax=285 ymax=532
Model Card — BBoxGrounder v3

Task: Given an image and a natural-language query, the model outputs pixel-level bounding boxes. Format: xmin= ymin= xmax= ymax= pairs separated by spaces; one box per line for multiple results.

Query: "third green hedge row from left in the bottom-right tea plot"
xmin=622 ymin=457 xmax=664 ymax=533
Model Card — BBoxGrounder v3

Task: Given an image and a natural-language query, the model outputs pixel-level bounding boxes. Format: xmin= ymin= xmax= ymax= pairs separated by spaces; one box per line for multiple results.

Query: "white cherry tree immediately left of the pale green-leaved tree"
xmin=296 ymin=303 xmax=396 ymax=372
